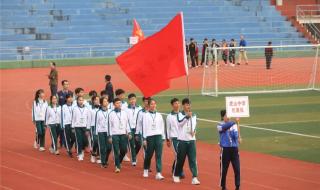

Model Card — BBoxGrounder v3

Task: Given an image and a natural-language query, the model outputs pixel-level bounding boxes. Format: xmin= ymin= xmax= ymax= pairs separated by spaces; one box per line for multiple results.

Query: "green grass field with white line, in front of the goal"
xmin=149 ymin=91 xmax=320 ymax=163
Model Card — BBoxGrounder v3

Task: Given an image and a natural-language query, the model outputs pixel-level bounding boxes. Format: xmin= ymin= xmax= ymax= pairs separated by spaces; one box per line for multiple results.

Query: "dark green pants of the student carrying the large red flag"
xmin=174 ymin=140 xmax=198 ymax=177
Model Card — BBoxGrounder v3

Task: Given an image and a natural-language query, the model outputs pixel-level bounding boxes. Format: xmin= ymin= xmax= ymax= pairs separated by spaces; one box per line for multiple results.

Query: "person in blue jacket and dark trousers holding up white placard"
xmin=217 ymin=110 xmax=240 ymax=190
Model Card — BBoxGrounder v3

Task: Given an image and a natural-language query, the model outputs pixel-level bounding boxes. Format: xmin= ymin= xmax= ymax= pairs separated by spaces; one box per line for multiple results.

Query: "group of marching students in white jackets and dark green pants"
xmin=32 ymin=77 xmax=200 ymax=185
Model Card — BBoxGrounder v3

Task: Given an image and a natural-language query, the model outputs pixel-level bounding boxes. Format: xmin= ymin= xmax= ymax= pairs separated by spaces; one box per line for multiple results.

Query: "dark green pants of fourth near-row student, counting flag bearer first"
xmin=98 ymin=132 xmax=112 ymax=166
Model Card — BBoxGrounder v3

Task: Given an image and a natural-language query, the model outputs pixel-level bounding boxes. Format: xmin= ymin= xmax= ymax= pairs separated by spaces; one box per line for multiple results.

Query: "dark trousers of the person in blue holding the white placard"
xmin=220 ymin=147 xmax=240 ymax=189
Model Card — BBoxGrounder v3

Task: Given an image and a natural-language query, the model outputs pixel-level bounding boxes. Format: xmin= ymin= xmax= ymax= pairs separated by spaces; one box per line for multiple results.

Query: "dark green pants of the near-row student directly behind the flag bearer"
xmin=143 ymin=135 xmax=163 ymax=172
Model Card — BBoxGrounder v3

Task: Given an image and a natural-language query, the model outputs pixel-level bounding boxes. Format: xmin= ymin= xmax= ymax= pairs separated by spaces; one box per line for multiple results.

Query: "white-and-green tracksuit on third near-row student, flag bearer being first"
xmin=108 ymin=109 xmax=131 ymax=169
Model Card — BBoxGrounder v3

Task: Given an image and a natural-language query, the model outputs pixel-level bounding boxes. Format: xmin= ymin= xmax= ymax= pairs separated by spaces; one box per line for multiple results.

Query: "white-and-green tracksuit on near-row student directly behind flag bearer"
xmin=142 ymin=111 xmax=166 ymax=173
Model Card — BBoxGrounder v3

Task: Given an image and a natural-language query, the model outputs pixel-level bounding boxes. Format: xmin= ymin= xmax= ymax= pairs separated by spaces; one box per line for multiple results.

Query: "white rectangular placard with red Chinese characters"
xmin=226 ymin=96 xmax=250 ymax=117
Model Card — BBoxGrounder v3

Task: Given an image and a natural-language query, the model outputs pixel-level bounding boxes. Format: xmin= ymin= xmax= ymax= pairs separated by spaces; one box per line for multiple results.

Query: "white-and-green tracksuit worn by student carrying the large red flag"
xmin=174 ymin=112 xmax=198 ymax=177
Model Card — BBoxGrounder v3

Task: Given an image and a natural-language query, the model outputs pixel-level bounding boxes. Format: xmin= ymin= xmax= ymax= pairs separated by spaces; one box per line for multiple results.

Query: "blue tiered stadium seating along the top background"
xmin=0 ymin=0 xmax=309 ymax=60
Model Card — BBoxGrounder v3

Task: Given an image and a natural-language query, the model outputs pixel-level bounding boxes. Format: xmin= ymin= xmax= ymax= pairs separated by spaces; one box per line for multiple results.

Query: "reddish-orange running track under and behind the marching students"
xmin=0 ymin=65 xmax=320 ymax=190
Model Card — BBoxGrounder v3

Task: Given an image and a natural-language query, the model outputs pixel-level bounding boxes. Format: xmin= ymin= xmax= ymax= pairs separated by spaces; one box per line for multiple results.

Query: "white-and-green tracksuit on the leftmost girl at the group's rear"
xmin=32 ymin=99 xmax=48 ymax=148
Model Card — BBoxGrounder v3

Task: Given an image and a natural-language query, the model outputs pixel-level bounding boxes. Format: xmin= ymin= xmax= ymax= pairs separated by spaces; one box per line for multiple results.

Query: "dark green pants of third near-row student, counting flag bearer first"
xmin=112 ymin=135 xmax=128 ymax=169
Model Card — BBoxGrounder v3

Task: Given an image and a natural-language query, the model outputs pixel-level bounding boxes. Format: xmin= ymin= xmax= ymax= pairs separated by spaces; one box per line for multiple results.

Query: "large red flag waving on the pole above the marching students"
xmin=116 ymin=13 xmax=188 ymax=97
